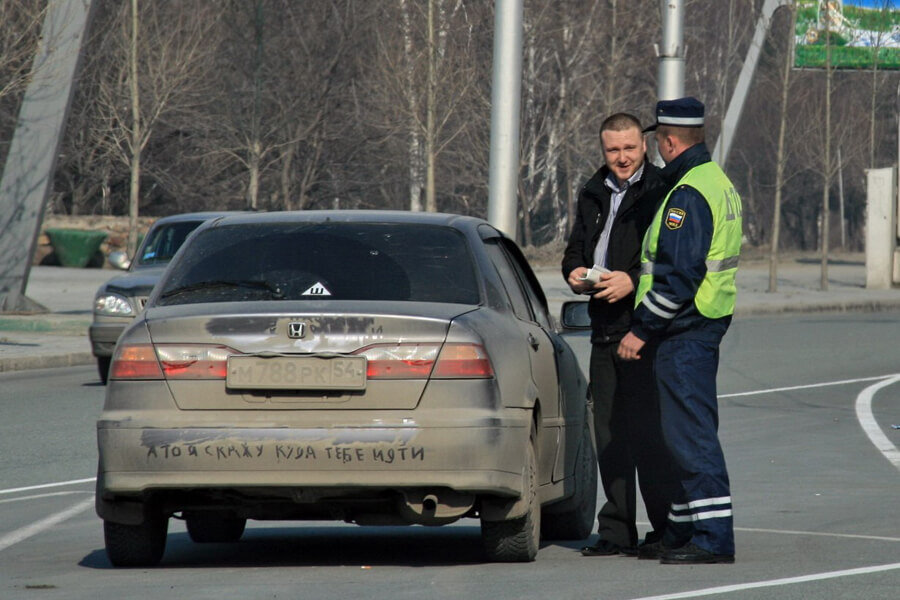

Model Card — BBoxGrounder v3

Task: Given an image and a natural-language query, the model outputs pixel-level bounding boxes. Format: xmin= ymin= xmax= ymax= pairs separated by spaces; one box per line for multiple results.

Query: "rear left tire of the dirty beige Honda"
xmin=103 ymin=516 xmax=169 ymax=567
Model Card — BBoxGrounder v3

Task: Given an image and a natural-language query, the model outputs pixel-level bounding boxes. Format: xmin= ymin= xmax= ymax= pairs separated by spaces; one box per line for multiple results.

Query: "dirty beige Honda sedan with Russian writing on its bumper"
xmin=96 ymin=211 xmax=597 ymax=566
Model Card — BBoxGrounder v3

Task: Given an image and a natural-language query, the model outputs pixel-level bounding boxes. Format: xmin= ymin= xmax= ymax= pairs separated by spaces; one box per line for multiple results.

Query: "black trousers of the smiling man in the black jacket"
xmin=590 ymin=342 xmax=679 ymax=546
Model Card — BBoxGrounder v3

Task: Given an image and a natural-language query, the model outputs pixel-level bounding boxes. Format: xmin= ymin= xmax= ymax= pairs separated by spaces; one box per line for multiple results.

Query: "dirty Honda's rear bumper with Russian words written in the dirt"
xmin=97 ymin=418 xmax=530 ymax=497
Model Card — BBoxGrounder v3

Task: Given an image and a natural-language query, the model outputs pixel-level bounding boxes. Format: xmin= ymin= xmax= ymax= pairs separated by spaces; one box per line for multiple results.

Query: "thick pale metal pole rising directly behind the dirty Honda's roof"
xmin=488 ymin=0 xmax=522 ymax=239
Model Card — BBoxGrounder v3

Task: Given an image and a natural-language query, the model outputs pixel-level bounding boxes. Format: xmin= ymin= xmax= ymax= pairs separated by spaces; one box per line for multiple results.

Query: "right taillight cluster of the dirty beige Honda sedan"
xmin=354 ymin=343 xmax=494 ymax=379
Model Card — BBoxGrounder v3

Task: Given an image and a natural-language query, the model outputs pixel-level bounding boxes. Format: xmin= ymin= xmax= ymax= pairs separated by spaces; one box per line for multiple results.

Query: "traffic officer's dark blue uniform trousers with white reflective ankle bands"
xmin=656 ymin=338 xmax=734 ymax=554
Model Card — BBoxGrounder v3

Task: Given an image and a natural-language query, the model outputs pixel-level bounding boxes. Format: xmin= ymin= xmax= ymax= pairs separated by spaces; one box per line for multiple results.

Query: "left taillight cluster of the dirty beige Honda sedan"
xmin=109 ymin=344 xmax=236 ymax=379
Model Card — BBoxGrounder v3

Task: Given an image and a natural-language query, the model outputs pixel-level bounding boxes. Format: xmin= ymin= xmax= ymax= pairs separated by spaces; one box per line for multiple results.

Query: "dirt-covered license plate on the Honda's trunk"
xmin=225 ymin=356 xmax=366 ymax=390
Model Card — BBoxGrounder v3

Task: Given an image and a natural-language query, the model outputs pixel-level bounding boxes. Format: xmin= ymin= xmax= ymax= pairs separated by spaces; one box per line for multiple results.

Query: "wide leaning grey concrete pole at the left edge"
xmin=0 ymin=0 xmax=92 ymax=312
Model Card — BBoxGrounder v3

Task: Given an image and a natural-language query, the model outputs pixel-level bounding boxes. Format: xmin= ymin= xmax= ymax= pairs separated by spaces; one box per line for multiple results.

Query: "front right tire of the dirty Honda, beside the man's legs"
xmin=541 ymin=415 xmax=597 ymax=540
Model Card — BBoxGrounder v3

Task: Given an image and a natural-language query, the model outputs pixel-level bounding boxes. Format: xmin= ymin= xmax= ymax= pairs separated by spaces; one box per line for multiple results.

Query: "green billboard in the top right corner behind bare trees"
xmin=794 ymin=0 xmax=900 ymax=69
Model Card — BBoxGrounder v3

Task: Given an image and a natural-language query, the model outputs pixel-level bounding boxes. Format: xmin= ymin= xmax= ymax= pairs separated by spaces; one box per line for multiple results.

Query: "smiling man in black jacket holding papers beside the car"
xmin=562 ymin=113 xmax=677 ymax=558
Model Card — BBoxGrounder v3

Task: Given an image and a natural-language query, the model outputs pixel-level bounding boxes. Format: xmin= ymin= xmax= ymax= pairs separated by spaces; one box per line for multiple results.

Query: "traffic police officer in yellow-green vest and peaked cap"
xmin=619 ymin=98 xmax=742 ymax=564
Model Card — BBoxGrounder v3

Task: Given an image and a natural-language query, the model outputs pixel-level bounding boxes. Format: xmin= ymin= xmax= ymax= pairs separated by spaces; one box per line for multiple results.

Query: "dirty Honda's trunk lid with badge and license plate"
xmin=147 ymin=303 xmax=472 ymax=410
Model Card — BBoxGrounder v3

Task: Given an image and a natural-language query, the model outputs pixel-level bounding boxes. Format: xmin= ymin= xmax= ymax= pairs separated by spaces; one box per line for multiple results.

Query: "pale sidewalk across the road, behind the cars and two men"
xmin=0 ymin=253 xmax=900 ymax=373
